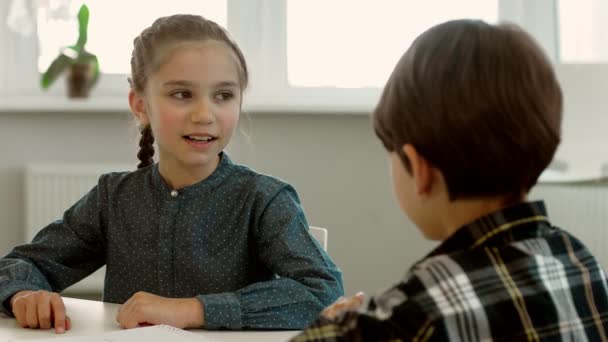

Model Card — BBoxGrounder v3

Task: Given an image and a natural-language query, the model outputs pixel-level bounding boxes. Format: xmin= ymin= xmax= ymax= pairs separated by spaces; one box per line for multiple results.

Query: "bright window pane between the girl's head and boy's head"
xmin=287 ymin=0 xmax=498 ymax=88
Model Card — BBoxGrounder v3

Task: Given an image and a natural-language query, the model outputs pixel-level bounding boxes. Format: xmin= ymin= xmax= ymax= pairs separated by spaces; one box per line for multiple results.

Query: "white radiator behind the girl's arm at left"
xmin=24 ymin=163 xmax=135 ymax=294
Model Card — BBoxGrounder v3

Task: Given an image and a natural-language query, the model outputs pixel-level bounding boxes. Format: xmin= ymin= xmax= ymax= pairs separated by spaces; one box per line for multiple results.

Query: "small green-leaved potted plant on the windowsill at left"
xmin=41 ymin=4 xmax=99 ymax=98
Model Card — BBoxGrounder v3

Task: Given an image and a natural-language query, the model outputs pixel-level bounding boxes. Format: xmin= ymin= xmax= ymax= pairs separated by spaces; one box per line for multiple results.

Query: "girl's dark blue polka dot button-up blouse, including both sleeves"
xmin=0 ymin=154 xmax=343 ymax=329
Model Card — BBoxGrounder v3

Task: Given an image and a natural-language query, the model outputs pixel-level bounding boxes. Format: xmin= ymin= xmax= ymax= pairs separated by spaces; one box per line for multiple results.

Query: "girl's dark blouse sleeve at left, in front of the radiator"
xmin=0 ymin=182 xmax=105 ymax=315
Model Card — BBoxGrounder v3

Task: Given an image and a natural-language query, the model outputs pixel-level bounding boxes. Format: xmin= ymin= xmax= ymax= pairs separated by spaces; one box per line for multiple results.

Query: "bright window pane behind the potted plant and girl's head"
xmin=37 ymin=0 xmax=227 ymax=73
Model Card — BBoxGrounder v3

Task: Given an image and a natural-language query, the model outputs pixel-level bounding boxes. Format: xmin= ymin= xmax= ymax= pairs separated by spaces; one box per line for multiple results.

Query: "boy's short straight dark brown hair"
xmin=373 ymin=20 xmax=562 ymax=200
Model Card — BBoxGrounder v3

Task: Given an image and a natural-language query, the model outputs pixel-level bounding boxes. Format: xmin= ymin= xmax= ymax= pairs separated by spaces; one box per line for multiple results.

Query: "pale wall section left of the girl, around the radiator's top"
xmin=0 ymin=113 xmax=136 ymax=248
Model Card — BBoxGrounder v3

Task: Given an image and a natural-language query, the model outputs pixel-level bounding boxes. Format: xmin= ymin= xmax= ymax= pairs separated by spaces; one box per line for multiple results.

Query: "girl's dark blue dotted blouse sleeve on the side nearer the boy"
xmin=199 ymin=185 xmax=344 ymax=329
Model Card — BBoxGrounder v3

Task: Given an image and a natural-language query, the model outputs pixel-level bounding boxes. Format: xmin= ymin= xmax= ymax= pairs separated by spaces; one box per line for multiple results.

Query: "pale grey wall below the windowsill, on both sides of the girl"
xmin=0 ymin=113 xmax=432 ymax=294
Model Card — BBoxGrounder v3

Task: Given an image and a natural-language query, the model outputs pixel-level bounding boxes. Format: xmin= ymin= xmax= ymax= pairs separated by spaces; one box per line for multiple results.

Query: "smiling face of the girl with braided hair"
xmin=138 ymin=40 xmax=242 ymax=177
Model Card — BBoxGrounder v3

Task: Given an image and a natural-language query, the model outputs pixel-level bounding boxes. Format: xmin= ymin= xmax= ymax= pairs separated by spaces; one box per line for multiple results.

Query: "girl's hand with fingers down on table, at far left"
xmin=11 ymin=291 xmax=72 ymax=334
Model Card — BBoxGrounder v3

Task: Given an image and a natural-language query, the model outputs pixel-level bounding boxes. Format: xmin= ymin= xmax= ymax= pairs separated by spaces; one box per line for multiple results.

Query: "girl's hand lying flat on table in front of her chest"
xmin=116 ymin=292 xmax=205 ymax=329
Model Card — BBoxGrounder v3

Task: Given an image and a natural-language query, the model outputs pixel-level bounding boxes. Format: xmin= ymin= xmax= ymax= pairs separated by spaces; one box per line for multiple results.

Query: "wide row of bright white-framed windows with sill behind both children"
xmin=0 ymin=0 xmax=608 ymax=113
